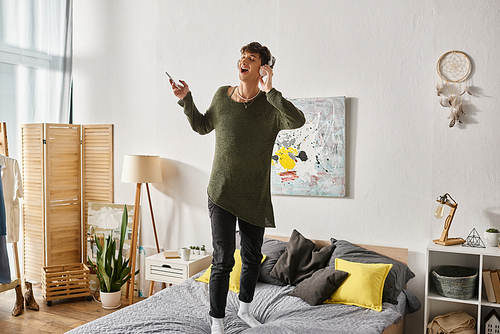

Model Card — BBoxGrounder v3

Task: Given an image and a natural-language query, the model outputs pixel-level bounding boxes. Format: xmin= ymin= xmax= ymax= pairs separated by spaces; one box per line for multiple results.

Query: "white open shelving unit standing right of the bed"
xmin=424 ymin=242 xmax=500 ymax=334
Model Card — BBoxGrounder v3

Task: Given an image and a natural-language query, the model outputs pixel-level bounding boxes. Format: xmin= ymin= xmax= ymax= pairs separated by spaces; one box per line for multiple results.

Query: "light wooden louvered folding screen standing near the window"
xmin=21 ymin=124 xmax=113 ymax=281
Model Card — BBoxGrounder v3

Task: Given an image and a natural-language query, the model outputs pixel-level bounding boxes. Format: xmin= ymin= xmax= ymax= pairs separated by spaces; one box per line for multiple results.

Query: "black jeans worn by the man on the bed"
xmin=208 ymin=199 xmax=265 ymax=318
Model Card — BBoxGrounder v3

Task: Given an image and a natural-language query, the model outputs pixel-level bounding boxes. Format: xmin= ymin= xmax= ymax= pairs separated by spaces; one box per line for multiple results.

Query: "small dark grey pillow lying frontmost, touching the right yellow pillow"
xmin=288 ymin=268 xmax=349 ymax=306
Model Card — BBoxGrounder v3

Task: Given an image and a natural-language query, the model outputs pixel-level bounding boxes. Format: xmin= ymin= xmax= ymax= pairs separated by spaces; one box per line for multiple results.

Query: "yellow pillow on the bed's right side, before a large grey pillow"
xmin=325 ymin=258 xmax=392 ymax=312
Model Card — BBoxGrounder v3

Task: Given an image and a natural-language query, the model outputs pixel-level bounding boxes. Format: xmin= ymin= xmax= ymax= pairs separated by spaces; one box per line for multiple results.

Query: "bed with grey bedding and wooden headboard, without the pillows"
xmin=68 ymin=235 xmax=420 ymax=334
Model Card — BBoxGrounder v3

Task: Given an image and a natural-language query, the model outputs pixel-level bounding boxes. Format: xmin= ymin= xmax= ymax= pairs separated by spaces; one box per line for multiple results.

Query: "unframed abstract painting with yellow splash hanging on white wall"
xmin=271 ymin=96 xmax=345 ymax=197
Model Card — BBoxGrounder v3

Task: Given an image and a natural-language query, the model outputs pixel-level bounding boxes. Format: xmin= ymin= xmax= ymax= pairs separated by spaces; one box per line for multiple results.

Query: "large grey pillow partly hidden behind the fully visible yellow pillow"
xmin=328 ymin=238 xmax=415 ymax=305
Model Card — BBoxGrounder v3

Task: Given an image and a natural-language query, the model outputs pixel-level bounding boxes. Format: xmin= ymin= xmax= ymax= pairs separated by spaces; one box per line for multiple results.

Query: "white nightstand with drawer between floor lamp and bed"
xmin=146 ymin=252 xmax=212 ymax=284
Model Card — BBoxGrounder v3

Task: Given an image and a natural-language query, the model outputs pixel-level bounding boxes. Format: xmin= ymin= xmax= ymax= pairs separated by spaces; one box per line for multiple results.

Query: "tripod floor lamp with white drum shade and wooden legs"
xmin=122 ymin=155 xmax=162 ymax=305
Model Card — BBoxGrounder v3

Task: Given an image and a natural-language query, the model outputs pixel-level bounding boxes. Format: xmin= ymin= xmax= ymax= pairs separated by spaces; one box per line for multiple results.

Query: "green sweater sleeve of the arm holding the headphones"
xmin=266 ymin=88 xmax=306 ymax=130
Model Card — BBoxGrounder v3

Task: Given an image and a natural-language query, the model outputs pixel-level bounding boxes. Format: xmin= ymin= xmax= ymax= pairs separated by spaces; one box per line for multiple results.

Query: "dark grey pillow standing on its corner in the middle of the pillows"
xmin=271 ymin=230 xmax=335 ymax=285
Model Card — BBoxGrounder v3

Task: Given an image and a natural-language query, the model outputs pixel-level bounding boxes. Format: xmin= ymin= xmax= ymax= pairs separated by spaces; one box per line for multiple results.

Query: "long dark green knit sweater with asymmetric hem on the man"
xmin=179 ymin=86 xmax=305 ymax=227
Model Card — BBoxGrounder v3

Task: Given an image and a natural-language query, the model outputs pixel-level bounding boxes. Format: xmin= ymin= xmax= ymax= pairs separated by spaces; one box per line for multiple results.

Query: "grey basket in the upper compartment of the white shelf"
xmin=432 ymin=266 xmax=477 ymax=299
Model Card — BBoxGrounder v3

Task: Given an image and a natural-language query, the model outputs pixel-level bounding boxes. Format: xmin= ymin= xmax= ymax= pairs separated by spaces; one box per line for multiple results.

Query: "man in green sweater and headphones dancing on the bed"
xmin=170 ymin=42 xmax=305 ymax=333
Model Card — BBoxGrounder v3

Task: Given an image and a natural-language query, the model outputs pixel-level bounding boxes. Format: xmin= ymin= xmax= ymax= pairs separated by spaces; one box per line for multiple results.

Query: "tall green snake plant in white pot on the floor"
xmin=88 ymin=205 xmax=139 ymax=309
